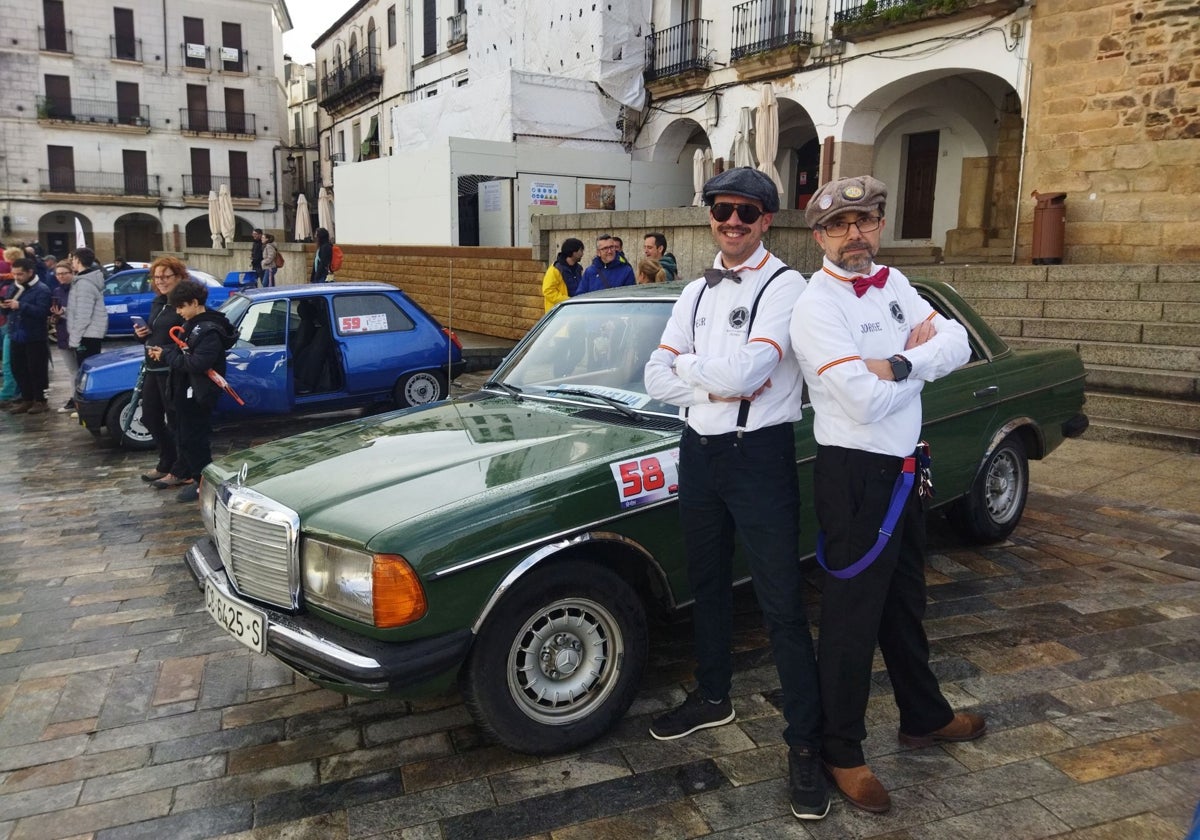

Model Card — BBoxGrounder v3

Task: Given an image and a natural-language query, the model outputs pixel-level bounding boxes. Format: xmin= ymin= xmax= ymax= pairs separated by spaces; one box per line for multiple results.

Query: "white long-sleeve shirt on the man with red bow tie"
xmin=791 ymin=259 xmax=971 ymax=457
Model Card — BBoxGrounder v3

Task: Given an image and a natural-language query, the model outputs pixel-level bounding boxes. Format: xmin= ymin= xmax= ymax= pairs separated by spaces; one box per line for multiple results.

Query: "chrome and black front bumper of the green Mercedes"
xmin=184 ymin=536 xmax=473 ymax=694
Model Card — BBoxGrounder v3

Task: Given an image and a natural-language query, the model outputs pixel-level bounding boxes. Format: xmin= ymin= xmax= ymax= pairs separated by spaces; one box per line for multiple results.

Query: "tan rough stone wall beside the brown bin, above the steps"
xmin=1018 ymin=0 xmax=1200 ymax=264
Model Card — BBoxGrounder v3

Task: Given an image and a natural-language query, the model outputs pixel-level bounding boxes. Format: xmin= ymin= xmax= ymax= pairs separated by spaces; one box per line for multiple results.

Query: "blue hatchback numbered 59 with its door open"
xmin=74 ymin=282 xmax=466 ymax=449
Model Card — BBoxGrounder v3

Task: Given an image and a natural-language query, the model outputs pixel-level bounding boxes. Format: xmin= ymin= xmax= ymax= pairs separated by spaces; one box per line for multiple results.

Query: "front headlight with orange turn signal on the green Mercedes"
xmin=300 ymin=539 xmax=426 ymax=628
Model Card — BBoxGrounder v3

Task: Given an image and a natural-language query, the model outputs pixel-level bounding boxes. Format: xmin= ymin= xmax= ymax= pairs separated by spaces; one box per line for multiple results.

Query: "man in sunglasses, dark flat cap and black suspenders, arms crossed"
xmin=646 ymin=167 xmax=829 ymax=820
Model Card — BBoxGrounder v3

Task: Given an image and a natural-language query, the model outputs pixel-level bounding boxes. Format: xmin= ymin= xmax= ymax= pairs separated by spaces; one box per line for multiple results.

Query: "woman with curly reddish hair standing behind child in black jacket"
xmin=133 ymin=257 xmax=191 ymax=490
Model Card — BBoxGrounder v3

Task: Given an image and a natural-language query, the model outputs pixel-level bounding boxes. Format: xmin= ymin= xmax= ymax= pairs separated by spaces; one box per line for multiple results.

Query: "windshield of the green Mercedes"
xmin=494 ymin=300 xmax=678 ymax=416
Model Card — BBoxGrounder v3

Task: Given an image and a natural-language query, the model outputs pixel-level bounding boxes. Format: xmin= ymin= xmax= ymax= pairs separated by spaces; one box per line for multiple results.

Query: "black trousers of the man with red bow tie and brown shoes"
xmin=812 ymin=446 xmax=954 ymax=767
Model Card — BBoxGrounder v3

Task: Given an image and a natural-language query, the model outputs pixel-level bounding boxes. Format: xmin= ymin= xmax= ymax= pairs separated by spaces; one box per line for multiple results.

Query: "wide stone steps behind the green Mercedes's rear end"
xmin=905 ymin=265 xmax=1200 ymax=452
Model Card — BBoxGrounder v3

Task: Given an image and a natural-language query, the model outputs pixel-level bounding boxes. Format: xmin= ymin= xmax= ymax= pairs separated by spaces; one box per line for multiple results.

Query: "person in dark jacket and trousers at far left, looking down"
xmin=2 ymin=257 xmax=50 ymax=414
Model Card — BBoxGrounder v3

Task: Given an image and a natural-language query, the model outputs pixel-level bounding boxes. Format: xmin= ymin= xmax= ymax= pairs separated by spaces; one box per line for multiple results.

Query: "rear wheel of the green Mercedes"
xmin=949 ymin=434 xmax=1030 ymax=542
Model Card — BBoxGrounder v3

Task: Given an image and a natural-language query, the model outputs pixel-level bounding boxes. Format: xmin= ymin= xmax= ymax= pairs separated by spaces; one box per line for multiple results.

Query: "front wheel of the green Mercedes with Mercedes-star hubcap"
xmin=462 ymin=563 xmax=647 ymax=755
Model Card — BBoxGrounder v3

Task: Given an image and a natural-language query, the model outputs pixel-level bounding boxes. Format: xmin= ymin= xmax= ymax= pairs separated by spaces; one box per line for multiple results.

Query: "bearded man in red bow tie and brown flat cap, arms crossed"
xmin=791 ymin=175 xmax=986 ymax=812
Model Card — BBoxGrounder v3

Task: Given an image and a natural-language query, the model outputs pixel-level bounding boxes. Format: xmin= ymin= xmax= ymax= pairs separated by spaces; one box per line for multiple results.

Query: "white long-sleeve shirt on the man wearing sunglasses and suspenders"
xmin=646 ymin=244 xmax=804 ymax=434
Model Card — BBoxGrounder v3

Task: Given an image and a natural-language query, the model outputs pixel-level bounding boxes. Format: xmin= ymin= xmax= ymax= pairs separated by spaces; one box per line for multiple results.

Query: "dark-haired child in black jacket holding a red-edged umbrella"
xmin=146 ymin=280 xmax=238 ymax=502
